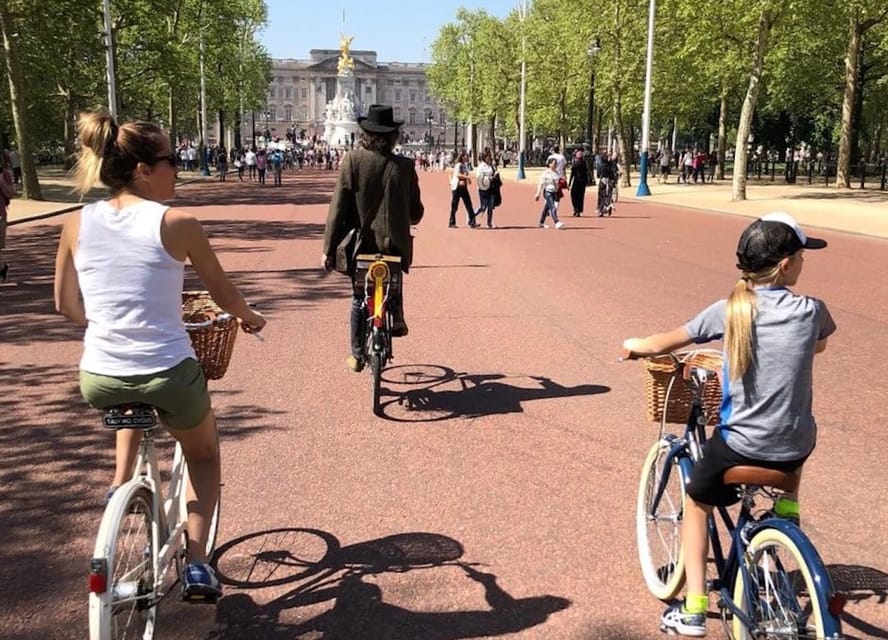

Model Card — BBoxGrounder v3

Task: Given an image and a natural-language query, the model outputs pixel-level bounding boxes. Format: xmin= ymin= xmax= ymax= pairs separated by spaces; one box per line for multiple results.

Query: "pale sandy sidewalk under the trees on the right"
xmin=502 ymin=167 xmax=888 ymax=239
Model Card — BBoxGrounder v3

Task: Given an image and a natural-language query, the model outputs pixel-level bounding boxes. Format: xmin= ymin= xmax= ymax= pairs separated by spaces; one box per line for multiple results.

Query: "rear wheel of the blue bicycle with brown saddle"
xmin=732 ymin=527 xmax=826 ymax=640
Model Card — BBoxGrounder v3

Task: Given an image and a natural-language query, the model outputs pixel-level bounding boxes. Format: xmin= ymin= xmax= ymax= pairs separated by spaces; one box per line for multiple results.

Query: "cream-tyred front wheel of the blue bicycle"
xmin=635 ymin=438 xmax=685 ymax=602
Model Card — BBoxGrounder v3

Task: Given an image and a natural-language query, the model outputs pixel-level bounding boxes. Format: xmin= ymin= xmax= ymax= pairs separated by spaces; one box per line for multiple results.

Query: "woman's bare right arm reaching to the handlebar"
xmin=161 ymin=209 xmax=265 ymax=331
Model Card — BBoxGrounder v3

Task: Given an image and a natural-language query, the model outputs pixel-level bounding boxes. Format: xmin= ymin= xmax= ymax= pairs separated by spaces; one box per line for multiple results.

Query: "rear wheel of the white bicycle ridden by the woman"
xmin=89 ymin=482 xmax=158 ymax=640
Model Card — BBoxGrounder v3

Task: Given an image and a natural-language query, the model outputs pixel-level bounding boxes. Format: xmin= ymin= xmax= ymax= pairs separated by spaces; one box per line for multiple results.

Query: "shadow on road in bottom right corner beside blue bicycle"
xmin=826 ymin=564 xmax=888 ymax=640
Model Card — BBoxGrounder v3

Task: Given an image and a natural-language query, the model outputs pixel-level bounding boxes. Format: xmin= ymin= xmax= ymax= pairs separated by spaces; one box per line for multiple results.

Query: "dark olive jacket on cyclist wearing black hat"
xmin=324 ymin=148 xmax=424 ymax=271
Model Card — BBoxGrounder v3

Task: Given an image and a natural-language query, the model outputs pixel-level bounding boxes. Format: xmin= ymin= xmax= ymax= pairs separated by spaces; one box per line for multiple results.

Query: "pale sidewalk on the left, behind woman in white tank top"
xmin=9 ymin=167 xmax=204 ymax=226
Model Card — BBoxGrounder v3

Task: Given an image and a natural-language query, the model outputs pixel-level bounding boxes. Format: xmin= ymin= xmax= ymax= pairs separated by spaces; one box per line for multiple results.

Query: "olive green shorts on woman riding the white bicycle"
xmin=80 ymin=358 xmax=210 ymax=430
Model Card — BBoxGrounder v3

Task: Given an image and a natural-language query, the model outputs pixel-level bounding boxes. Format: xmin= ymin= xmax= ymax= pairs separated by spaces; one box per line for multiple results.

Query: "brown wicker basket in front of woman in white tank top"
xmin=182 ymin=291 xmax=237 ymax=380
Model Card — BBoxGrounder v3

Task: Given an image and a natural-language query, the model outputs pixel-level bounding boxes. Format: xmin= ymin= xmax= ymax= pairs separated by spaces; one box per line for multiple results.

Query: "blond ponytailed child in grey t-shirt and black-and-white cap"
xmin=623 ymin=212 xmax=836 ymax=637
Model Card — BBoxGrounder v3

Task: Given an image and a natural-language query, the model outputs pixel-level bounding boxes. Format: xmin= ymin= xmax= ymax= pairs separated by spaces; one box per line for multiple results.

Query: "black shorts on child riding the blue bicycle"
xmin=687 ymin=429 xmax=811 ymax=507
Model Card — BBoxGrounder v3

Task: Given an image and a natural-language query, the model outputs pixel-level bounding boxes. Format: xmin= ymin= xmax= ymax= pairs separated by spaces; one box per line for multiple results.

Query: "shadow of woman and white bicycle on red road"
xmin=207 ymin=528 xmax=571 ymax=640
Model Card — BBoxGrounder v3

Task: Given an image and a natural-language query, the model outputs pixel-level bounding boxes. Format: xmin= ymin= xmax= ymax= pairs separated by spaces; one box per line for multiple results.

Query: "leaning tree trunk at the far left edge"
xmin=0 ymin=2 xmax=43 ymax=200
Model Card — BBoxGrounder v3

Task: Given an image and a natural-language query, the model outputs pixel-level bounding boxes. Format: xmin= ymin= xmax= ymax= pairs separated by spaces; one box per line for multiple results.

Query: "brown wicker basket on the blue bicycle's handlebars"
xmin=644 ymin=350 xmax=724 ymax=425
